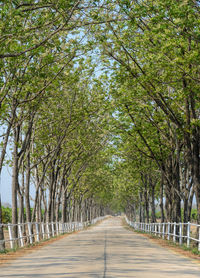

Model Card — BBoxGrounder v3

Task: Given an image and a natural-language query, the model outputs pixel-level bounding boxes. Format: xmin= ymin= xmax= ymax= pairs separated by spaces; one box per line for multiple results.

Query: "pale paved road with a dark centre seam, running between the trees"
xmin=0 ymin=217 xmax=200 ymax=278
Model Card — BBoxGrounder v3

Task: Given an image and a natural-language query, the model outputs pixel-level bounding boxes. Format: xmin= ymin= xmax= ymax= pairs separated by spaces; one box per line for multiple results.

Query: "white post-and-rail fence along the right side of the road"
xmin=125 ymin=216 xmax=200 ymax=251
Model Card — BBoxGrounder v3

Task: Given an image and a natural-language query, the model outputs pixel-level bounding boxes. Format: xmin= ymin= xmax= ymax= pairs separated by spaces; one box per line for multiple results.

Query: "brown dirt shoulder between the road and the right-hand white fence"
xmin=122 ymin=220 xmax=200 ymax=264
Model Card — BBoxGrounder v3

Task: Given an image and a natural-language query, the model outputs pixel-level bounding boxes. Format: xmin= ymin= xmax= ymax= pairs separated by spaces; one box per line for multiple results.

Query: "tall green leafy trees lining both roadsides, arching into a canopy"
xmin=0 ymin=0 xmax=200 ymax=248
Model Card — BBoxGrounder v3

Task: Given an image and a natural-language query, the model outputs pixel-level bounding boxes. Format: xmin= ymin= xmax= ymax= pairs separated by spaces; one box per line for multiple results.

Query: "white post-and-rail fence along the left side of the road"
xmin=0 ymin=216 xmax=105 ymax=249
